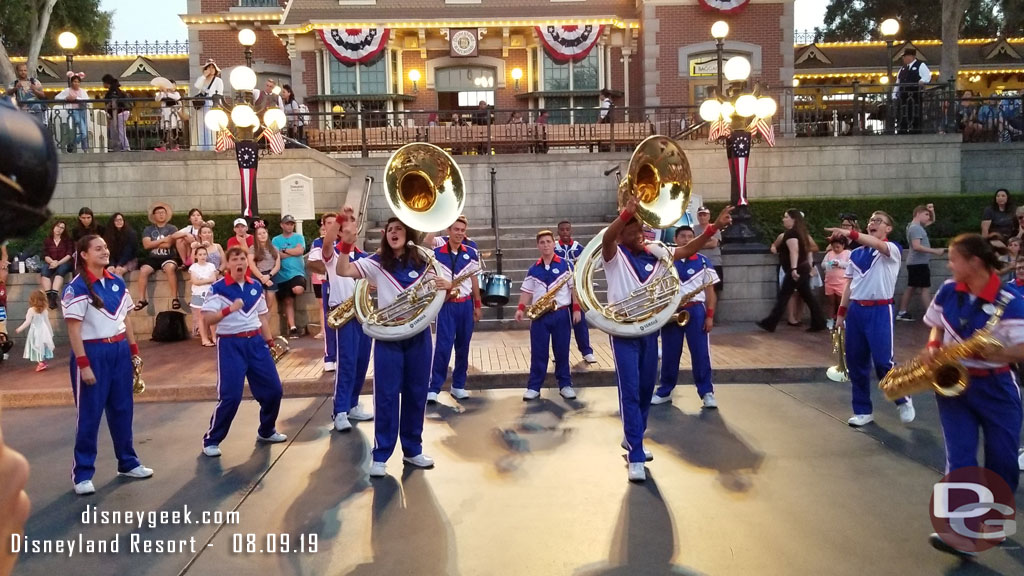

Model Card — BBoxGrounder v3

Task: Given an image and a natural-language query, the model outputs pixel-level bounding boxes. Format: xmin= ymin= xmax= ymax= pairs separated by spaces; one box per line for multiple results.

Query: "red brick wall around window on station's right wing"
xmin=655 ymin=3 xmax=783 ymax=106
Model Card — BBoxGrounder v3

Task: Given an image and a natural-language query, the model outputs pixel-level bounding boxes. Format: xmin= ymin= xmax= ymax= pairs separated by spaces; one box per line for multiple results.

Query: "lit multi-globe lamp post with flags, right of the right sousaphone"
xmin=700 ymin=52 xmax=778 ymax=253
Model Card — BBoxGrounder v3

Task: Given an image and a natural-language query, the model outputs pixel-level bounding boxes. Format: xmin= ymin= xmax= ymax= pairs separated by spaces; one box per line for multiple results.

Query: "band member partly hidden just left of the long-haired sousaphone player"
xmin=323 ymin=210 xmax=374 ymax=431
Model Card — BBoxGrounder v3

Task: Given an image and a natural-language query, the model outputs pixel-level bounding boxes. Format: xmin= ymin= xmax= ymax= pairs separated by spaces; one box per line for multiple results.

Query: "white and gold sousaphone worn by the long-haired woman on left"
xmin=353 ymin=142 xmax=466 ymax=341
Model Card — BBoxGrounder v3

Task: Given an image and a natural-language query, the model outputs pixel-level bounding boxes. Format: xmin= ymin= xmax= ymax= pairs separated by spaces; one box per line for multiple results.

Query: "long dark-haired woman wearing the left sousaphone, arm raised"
xmin=327 ymin=216 xmax=452 ymax=478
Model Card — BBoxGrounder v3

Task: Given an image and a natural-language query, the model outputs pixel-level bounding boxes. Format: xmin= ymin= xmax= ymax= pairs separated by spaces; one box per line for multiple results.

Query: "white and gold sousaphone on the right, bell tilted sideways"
xmin=574 ymin=136 xmax=692 ymax=338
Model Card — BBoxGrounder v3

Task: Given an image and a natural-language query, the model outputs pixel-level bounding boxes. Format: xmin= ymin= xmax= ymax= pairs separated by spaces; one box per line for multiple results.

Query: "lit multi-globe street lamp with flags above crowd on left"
xmin=205 ymin=29 xmax=288 ymax=221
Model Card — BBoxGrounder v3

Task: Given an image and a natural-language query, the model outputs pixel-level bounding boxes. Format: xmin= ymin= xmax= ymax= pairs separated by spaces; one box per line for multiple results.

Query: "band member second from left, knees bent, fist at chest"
xmin=203 ymin=246 xmax=288 ymax=458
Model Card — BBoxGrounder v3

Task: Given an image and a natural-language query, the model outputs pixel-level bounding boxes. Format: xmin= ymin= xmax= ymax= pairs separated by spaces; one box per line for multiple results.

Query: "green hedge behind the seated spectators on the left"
xmin=7 ymin=210 xmax=319 ymax=259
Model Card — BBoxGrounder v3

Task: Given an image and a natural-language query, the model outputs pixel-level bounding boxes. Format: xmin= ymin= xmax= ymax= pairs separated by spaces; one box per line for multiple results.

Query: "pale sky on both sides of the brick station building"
xmin=100 ymin=0 xmax=828 ymax=42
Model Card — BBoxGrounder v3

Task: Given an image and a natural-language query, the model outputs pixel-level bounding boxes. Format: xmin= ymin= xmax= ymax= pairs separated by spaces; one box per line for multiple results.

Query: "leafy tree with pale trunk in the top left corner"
xmin=0 ymin=0 xmax=114 ymax=83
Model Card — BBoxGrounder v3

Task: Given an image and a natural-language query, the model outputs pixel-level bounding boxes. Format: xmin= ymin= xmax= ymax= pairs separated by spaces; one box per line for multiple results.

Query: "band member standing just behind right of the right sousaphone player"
xmin=650 ymin=225 xmax=719 ymax=409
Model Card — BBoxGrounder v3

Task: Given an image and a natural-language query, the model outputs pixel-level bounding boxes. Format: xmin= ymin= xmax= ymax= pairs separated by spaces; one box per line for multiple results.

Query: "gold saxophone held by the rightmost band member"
xmin=879 ymin=298 xmax=1007 ymax=400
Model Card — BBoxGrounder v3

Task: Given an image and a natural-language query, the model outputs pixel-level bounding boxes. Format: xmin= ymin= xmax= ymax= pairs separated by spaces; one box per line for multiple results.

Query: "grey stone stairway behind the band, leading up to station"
xmin=366 ymin=220 xmax=608 ymax=330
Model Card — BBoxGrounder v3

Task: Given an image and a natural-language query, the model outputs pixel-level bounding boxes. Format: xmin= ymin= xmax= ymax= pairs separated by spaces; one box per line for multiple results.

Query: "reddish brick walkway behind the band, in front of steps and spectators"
xmin=0 ymin=323 xmax=928 ymax=407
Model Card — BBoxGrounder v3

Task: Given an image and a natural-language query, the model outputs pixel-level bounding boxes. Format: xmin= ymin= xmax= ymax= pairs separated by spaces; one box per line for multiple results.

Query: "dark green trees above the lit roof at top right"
xmin=814 ymin=0 xmax=999 ymax=42
